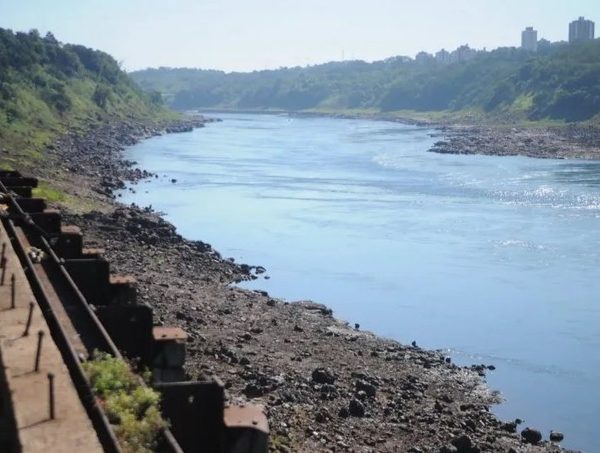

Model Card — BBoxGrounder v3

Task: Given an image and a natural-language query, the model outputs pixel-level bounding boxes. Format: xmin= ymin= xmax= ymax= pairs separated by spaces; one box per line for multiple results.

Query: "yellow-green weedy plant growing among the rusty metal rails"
xmin=83 ymin=353 xmax=167 ymax=453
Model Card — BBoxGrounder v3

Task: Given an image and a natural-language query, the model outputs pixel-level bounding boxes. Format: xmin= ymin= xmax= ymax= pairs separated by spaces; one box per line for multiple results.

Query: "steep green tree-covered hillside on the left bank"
xmin=0 ymin=28 xmax=174 ymax=157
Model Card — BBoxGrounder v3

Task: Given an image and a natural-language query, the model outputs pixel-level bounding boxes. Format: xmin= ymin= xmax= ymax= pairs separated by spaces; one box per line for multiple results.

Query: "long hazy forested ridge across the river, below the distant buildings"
xmin=131 ymin=40 xmax=600 ymax=121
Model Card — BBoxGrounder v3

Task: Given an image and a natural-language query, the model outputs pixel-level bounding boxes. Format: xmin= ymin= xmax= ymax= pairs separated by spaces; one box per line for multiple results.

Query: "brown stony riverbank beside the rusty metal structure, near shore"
xmin=38 ymin=118 xmax=576 ymax=452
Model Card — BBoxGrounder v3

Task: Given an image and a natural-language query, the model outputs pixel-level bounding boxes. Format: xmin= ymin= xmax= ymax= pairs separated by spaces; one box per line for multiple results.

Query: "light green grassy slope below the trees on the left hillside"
xmin=0 ymin=67 xmax=180 ymax=172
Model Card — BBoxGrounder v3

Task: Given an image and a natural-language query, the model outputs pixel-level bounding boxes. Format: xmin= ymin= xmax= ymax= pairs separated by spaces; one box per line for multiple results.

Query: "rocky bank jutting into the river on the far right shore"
xmin=430 ymin=125 xmax=600 ymax=159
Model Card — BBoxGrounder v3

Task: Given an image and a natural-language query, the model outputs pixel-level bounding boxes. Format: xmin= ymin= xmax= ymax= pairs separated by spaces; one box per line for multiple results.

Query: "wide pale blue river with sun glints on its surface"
xmin=122 ymin=114 xmax=600 ymax=452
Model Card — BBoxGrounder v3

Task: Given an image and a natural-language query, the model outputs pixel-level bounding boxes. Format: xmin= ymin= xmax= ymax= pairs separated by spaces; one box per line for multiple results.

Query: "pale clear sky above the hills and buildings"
xmin=0 ymin=0 xmax=600 ymax=71
